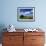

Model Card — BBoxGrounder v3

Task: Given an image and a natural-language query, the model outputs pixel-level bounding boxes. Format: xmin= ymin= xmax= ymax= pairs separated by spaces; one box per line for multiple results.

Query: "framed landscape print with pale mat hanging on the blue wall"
xmin=17 ymin=7 xmax=35 ymax=22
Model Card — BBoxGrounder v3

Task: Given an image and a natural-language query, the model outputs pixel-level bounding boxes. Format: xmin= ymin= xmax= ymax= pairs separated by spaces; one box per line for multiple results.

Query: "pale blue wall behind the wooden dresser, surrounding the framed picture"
xmin=0 ymin=0 xmax=46 ymax=28
